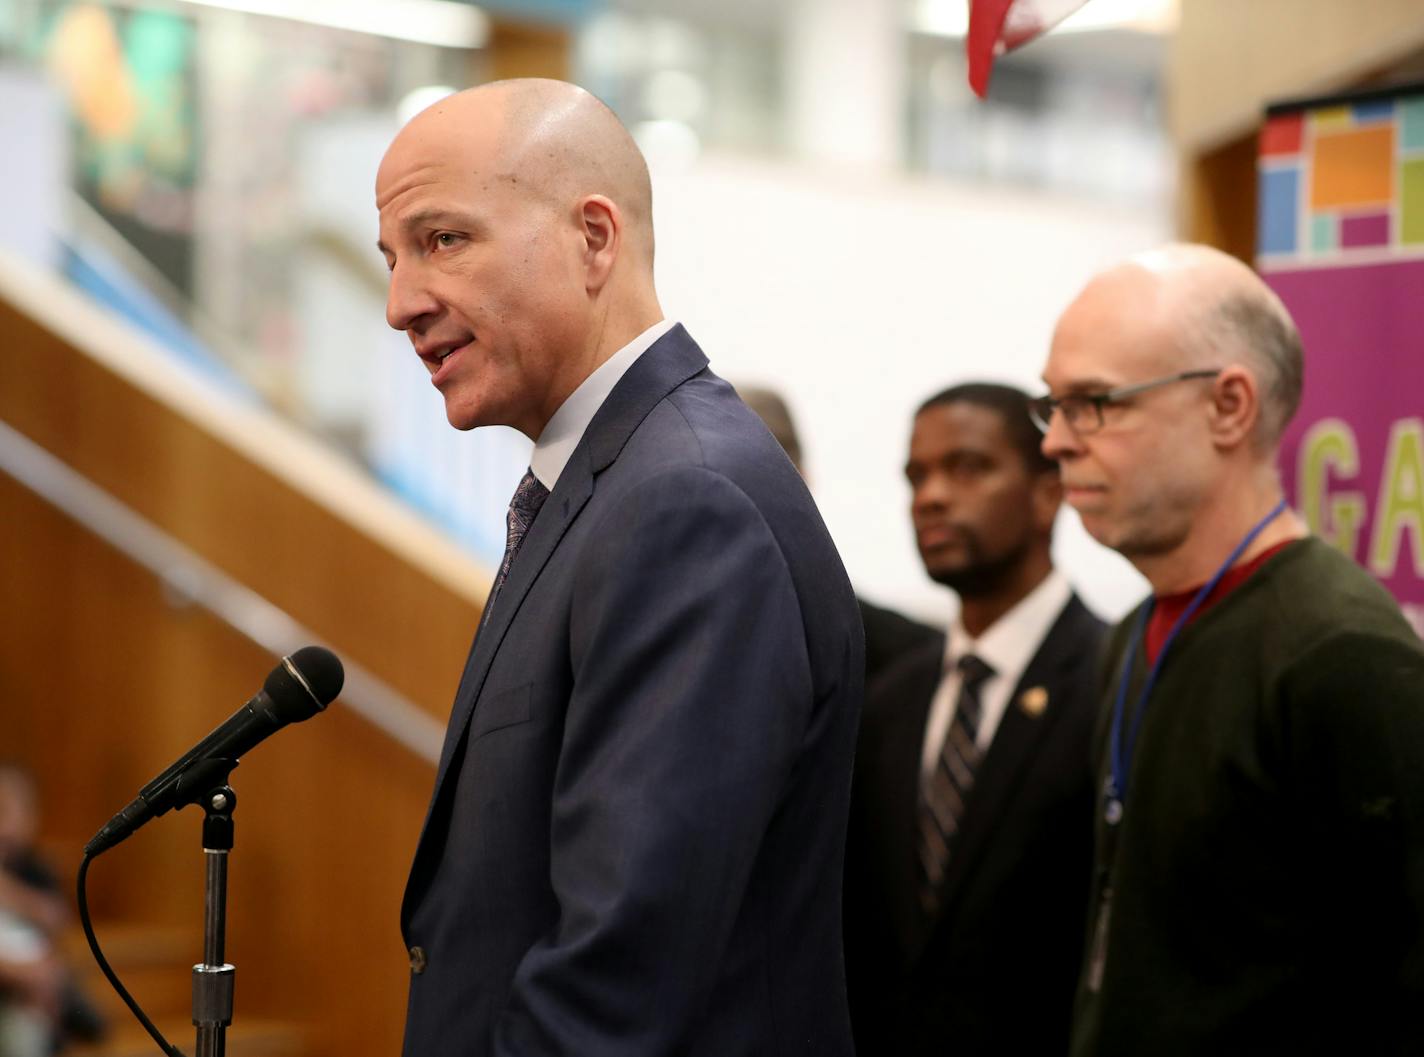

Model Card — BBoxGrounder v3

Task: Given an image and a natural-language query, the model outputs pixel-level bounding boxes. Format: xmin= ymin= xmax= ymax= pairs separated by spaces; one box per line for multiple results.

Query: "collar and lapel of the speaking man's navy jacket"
xmin=426 ymin=323 xmax=708 ymax=825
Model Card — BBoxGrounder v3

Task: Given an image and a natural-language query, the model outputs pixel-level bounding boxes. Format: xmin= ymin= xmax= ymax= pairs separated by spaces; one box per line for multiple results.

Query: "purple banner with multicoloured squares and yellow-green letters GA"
xmin=1256 ymin=85 xmax=1424 ymax=635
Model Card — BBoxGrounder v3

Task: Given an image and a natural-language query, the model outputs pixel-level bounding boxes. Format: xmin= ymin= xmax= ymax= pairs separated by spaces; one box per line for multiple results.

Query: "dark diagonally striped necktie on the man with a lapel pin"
xmin=918 ymin=654 xmax=994 ymax=917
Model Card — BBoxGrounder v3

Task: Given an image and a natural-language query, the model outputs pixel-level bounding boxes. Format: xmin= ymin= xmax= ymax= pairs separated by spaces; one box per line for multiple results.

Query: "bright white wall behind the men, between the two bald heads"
xmin=654 ymin=158 xmax=1171 ymax=623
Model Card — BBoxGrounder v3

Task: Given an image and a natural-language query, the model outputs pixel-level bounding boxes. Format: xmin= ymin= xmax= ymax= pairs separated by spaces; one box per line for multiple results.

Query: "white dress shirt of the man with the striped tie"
xmin=920 ymin=568 xmax=1071 ymax=781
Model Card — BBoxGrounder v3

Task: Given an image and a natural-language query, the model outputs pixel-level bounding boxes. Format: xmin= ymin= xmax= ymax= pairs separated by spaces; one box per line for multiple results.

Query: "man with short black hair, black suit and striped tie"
xmin=846 ymin=383 xmax=1104 ymax=1057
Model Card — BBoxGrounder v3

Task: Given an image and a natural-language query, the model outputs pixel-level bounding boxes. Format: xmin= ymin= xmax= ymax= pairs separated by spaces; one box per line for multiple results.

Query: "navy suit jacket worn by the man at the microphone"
xmin=402 ymin=326 xmax=864 ymax=1057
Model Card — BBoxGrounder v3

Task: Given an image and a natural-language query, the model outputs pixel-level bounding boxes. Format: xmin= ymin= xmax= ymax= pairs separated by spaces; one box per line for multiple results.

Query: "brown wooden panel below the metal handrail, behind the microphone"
xmin=0 ymin=476 xmax=433 ymax=1057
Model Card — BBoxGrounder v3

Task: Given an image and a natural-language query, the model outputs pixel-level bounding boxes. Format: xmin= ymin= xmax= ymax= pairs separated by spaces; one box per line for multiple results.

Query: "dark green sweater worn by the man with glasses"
xmin=1072 ymin=538 xmax=1424 ymax=1057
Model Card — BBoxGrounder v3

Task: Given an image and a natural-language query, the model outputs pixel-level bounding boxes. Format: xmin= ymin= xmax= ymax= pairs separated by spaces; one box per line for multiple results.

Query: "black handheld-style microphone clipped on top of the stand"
xmin=84 ymin=645 xmax=346 ymax=856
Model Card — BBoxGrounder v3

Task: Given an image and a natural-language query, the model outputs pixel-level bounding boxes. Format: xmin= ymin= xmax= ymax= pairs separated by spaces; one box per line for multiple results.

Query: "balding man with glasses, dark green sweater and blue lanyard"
xmin=1035 ymin=245 xmax=1424 ymax=1057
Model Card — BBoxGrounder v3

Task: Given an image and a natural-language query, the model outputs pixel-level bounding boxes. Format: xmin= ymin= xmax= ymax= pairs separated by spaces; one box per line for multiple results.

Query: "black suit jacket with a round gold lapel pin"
xmin=846 ymin=597 xmax=1105 ymax=1057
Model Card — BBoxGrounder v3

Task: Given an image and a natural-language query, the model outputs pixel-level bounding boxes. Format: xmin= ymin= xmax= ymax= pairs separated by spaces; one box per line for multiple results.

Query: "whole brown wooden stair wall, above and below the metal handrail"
xmin=0 ymin=262 xmax=498 ymax=1057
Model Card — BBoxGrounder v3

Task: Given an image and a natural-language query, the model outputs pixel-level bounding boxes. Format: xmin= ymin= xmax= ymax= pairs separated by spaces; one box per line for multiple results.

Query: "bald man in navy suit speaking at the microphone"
xmin=376 ymin=80 xmax=863 ymax=1057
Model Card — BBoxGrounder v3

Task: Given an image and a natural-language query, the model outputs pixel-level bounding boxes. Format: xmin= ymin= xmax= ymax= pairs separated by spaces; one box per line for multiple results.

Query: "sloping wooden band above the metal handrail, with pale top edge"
xmin=0 ymin=262 xmax=488 ymax=719
